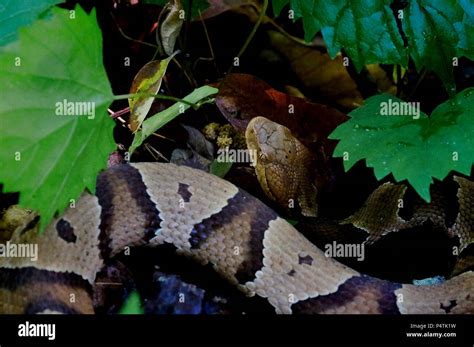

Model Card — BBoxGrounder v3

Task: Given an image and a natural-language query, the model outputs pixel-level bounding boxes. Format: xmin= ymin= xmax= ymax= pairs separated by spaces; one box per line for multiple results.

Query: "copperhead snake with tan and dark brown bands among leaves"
xmin=0 ymin=118 xmax=474 ymax=314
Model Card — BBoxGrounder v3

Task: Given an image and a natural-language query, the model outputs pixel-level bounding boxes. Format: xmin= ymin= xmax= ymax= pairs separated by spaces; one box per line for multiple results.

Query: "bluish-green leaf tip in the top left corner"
xmin=0 ymin=0 xmax=62 ymax=46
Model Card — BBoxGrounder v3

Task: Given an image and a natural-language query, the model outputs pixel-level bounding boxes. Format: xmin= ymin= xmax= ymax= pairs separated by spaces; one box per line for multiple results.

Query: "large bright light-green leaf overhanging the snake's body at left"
xmin=0 ymin=7 xmax=114 ymax=227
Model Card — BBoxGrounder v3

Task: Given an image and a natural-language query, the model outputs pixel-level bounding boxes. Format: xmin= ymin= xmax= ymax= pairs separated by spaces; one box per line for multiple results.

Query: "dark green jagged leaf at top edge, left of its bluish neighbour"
xmin=277 ymin=0 xmax=408 ymax=71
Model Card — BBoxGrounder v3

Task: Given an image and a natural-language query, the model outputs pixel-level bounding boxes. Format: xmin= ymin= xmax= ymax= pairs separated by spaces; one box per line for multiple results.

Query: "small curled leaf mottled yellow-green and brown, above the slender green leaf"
xmin=128 ymin=53 xmax=176 ymax=131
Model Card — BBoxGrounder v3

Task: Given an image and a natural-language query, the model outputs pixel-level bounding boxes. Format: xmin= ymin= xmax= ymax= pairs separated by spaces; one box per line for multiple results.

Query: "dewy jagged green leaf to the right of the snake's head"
xmin=330 ymin=88 xmax=474 ymax=201
